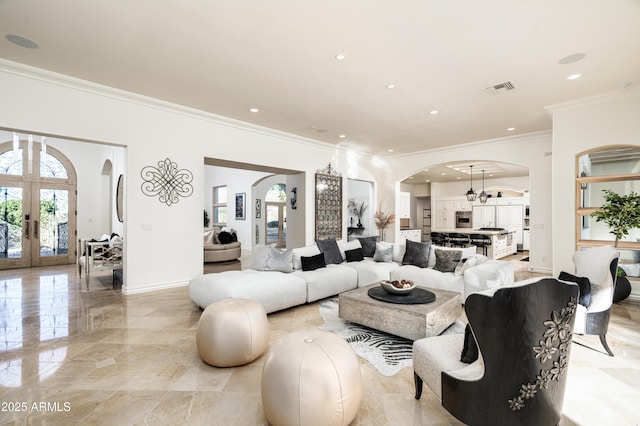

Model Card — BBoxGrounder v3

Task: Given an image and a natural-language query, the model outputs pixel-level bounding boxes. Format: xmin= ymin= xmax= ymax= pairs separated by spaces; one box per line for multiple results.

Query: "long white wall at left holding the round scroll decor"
xmin=0 ymin=60 xmax=381 ymax=294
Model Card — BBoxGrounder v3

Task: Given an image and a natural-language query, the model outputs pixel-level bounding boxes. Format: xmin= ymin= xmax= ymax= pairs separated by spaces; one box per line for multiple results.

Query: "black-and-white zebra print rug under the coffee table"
xmin=320 ymin=298 xmax=413 ymax=376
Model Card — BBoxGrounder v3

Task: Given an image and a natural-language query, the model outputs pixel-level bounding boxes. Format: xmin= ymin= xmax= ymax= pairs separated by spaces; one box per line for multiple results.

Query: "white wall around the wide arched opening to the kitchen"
xmin=385 ymin=132 xmax=553 ymax=273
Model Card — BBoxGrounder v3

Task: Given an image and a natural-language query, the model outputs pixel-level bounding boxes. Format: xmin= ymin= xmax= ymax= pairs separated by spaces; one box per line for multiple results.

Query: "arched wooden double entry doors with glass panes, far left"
xmin=0 ymin=136 xmax=77 ymax=269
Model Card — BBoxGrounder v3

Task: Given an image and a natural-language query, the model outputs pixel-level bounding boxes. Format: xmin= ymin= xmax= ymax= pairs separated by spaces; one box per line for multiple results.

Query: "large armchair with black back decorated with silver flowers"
xmin=413 ymin=278 xmax=578 ymax=426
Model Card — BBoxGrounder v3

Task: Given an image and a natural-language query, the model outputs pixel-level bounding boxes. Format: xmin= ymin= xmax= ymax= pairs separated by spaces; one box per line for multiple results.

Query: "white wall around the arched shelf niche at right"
xmin=544 ymin=89 xmax=640 ymax=297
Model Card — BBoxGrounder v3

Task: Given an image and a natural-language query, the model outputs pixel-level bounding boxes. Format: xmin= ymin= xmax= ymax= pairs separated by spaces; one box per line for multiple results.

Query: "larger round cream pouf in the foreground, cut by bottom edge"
xmin=262 ymin=330 xmax=362 ymax=426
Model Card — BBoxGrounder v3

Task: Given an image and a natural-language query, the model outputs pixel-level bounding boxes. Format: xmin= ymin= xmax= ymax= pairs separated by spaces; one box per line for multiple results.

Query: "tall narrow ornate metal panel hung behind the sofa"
xmin=316 ymin=164 xmax=342 ymax=240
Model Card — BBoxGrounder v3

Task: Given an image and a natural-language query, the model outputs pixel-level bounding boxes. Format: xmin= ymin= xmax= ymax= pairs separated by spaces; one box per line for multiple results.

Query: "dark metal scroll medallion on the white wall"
xmin=140 ymin=158 xmax=193 ymax=206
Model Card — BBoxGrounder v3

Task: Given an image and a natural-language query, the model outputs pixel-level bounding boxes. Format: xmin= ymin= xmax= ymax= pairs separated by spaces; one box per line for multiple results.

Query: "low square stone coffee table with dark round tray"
xmin=338 ymin=283 xmax=462 ymax=340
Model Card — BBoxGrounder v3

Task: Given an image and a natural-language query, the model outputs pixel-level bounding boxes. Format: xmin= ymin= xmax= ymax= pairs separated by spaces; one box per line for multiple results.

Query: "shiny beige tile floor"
xmin=0 ymin=256 xmax=640 ymax=425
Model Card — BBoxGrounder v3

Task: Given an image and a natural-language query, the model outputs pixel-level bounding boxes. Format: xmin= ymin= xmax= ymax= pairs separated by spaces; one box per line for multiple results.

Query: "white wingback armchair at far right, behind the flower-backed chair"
xmin=573 ymin=246 xmax=620 ymax=356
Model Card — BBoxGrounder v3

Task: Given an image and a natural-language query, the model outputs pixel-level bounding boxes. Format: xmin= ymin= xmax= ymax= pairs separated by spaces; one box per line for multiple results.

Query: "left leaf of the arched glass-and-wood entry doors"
xmin=0 ymin=184 xmax=31 ymax=269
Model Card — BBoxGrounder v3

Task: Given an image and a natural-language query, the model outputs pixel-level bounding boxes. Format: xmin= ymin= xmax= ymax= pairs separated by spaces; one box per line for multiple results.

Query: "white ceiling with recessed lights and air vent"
xmin=0 ymin=0 xmax=640 ymax=161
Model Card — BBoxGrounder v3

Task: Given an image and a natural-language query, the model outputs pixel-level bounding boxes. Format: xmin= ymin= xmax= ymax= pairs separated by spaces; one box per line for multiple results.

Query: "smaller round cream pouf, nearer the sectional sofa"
xmin=196 ymin=299 xmax=269 ymax=367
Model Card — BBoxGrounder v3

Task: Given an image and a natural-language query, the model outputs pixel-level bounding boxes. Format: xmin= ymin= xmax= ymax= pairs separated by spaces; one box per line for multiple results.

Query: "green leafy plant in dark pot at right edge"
xmin=591 ymin=189 xmax=640 ymax=302
